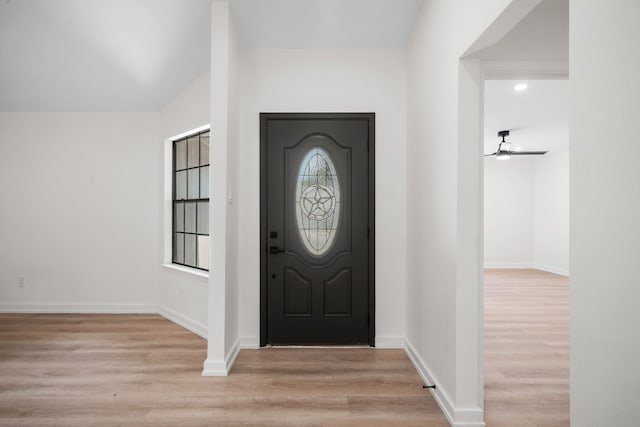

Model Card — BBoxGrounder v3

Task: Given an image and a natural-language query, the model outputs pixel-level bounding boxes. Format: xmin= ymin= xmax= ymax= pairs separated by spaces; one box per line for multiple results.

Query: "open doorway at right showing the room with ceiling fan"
xmin=483 ymin=67 xmax=570 ymax=425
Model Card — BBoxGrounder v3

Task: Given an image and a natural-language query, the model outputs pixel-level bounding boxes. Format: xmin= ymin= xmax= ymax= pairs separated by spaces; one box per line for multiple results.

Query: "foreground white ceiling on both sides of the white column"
xmin=0 ymin=0 xmax=422 ymax=111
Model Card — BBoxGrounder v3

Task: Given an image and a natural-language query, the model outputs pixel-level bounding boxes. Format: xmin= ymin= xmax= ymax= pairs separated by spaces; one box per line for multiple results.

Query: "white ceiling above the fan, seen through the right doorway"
xmin=484 ymin=80 xmax=569 ymax=154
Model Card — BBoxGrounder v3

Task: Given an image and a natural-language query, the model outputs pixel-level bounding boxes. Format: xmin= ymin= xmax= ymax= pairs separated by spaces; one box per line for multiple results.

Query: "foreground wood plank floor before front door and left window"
xmin=0 ymin=314 xmax=449 ymax=427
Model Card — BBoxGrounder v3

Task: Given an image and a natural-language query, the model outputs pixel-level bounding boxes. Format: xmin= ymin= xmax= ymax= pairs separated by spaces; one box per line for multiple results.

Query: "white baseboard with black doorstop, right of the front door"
xmin=405 ymin=340 xmax=485 ymax=427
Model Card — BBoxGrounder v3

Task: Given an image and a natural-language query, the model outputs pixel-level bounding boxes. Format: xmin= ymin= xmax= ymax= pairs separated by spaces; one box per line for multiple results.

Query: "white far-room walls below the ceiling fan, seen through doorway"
xmin=484 ymin=149 xmax=569 ymax=276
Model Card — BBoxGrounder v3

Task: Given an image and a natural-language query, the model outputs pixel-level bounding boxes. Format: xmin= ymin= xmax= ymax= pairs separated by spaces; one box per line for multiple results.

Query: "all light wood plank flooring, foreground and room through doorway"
xmin=0 ymin=270 xmax=569 ymax=427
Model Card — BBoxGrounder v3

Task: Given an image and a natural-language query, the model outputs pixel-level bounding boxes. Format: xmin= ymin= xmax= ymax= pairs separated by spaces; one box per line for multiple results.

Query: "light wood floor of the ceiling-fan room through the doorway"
xmin=484 ymin=270 xmax=569 ymax=427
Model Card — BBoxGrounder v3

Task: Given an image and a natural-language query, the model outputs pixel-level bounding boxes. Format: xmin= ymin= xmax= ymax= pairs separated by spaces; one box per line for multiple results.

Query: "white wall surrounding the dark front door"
xmin=237 ymin=49 xmax=407 ymax=345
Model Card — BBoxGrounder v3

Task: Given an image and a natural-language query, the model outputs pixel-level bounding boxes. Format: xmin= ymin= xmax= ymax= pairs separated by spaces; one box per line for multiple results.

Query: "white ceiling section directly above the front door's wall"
xmin=231 ymin=0 xmax=422 ymax=49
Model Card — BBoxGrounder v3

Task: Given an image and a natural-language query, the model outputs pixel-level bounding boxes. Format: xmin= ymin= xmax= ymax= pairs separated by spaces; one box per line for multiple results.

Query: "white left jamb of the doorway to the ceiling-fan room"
xmin=456 ymin=59 xmax=484 ymax=423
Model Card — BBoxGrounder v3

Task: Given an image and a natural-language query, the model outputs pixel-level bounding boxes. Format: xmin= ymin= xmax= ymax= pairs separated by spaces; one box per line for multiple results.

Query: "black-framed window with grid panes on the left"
xmin=172 ymin=130 xmax=209 ymax=271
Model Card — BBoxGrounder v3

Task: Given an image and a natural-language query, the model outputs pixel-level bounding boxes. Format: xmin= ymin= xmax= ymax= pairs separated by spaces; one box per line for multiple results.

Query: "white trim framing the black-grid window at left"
xmin=162 ymin=124 xmax=211 ymax=277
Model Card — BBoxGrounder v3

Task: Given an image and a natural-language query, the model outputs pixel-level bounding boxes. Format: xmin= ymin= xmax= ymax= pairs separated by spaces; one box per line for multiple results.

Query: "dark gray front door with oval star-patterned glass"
xmin=261 ymin=114 xmax=374 ymax=345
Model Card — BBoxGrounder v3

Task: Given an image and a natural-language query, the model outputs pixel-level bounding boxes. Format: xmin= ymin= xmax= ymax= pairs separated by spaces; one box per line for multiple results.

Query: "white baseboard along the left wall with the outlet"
xmin=0 ymin=303 xmax=158 ymax=314
